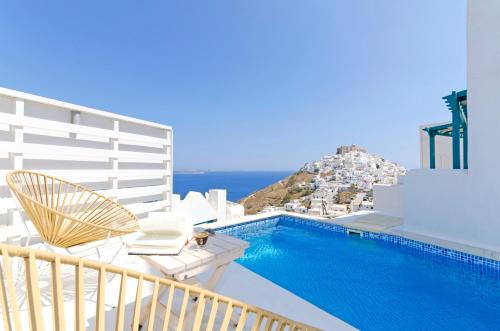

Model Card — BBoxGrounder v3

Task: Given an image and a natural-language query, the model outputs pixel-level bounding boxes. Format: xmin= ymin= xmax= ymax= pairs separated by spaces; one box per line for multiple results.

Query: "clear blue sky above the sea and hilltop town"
xmin=0 ymin=0 xmax=466 ymax=170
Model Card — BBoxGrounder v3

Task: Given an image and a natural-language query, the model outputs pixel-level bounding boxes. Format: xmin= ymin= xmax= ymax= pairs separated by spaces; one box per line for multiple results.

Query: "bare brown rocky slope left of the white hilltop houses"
xmin=238 ymin=171 xmax=313 ymax=215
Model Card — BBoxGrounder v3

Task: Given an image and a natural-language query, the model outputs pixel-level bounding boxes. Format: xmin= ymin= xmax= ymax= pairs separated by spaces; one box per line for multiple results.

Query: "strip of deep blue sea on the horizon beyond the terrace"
xmin=174 ymin=171 xmax=293 ymax=202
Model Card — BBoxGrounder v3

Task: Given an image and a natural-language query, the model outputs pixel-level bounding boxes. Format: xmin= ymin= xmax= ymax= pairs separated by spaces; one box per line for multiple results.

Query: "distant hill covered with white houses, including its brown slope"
xmin=240 ymin=145 xmax=405 ymax=217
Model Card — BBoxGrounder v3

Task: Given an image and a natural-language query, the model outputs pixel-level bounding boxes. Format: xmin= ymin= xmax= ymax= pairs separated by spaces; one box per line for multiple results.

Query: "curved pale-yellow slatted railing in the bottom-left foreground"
xmin=0 ymin=245 xmax=317 ymax=331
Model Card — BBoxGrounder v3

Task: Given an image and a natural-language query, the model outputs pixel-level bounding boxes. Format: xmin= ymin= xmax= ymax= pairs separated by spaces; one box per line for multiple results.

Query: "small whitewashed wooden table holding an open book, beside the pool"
xmin=137 ymin=233 xmax=249 ymax=324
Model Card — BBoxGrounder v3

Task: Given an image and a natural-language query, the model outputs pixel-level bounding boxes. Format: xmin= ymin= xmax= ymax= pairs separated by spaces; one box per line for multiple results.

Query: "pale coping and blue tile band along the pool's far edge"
xmin=206 ymin=211 xmax=500 ymax=277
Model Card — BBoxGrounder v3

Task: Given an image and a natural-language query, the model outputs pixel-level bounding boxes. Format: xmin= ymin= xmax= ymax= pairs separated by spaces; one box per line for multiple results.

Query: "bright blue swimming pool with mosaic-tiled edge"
xmin=218 ymin=216 xmax=500 ymax=330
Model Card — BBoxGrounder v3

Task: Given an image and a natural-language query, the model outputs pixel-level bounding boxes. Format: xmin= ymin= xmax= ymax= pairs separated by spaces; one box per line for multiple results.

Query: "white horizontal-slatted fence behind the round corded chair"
xmin=0 ymin=88 xmax=173 ymax=244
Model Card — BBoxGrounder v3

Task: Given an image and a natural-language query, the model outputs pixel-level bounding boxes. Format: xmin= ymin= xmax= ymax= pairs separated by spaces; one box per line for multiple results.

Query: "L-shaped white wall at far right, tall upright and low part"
xmin=374 ymin=0 xmax=500 ymax=251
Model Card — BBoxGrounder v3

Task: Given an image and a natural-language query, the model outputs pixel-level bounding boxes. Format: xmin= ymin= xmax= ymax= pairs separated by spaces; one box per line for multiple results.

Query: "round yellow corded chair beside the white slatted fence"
xmin=7 ymin=170 xmax=138 ymax=248
